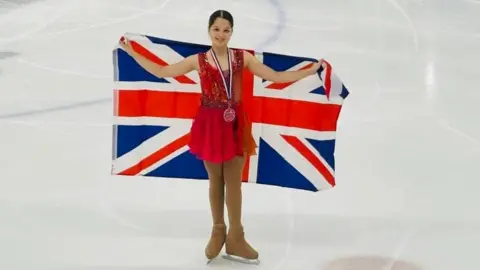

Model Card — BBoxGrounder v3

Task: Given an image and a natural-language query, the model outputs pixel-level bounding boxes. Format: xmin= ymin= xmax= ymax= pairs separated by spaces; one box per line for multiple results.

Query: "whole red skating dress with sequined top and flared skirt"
xmin=188 ymin=49 xmax=256 ymax=163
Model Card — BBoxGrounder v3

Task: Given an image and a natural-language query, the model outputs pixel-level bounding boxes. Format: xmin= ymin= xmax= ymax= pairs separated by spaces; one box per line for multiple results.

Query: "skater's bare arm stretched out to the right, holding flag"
xmin=243 ymin=51 xmax=321 ymax=83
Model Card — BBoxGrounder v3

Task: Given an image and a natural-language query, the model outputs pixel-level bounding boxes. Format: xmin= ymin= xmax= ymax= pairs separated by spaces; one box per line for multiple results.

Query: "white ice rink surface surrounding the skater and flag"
xmin=0 ymin=0 xmax=480 ymax=270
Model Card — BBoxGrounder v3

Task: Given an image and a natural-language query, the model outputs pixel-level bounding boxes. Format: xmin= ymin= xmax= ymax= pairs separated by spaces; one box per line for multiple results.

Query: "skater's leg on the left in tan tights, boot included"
xmin=204 ymin=161 xmax=226 ymax=260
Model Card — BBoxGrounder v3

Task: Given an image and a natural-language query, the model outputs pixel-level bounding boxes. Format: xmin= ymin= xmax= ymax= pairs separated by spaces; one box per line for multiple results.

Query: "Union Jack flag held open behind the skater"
xmin=112 ymin=34 xmax=349 ymax=191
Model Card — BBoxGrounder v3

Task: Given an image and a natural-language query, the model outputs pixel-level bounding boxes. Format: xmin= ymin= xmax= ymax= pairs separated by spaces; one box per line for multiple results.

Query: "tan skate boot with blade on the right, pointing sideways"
xmin=223 ymin=227 xmax=260 ymax=265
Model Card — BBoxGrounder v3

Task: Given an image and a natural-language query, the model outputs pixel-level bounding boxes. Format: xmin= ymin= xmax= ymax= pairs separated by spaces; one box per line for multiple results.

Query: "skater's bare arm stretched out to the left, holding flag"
xmin=120 ymin=39 xmax=197 ymax=78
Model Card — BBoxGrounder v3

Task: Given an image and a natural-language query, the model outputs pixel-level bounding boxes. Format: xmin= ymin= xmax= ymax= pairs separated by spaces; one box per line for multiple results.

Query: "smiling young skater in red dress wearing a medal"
xmin=120 ymin=10 xmax=321 ymax=261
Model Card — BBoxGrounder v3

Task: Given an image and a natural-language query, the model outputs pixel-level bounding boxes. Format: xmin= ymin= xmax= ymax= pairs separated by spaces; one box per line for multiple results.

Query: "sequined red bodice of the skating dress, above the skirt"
xmin=199 ymin=50 xmax=243 ymax=107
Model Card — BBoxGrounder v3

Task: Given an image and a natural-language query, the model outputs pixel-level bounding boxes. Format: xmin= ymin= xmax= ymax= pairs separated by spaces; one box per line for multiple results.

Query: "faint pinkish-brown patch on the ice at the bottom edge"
xmin=321 ymin=256 xmax=421 ymax=270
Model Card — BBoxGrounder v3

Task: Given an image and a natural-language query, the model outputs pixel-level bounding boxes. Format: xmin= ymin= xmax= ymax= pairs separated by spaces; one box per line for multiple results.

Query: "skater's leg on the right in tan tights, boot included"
xmin=223 ymin=157 xmax=258 ymax=260
